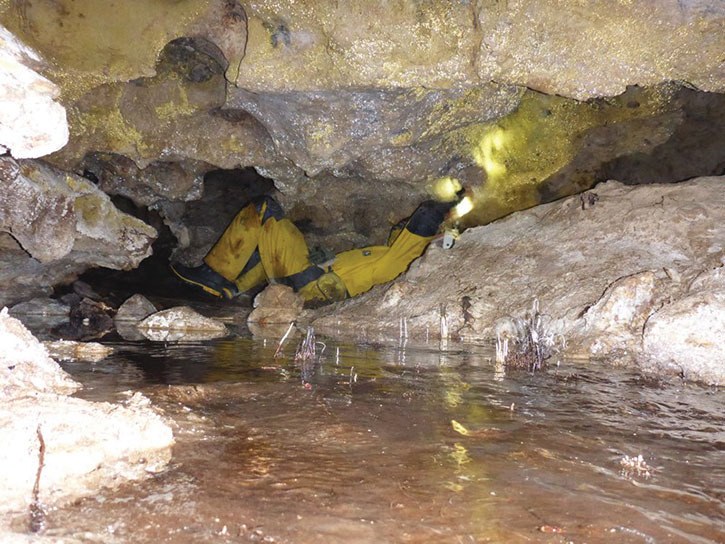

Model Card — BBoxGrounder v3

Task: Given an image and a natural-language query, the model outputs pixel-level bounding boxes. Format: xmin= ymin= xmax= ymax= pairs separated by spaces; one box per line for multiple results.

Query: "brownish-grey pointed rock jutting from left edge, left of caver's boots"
xmin=0 ymin=156 xmax=156 ymax=308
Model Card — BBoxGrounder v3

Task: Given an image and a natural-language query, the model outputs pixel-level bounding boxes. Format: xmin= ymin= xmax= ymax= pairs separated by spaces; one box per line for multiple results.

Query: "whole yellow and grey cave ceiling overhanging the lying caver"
xmin=0 ymin=0 xmax=725 ymax=278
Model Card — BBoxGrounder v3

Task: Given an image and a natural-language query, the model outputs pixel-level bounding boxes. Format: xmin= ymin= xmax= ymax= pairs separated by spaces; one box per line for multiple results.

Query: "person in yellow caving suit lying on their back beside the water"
xmin=171 ymin=189 xmax=465 ymax=304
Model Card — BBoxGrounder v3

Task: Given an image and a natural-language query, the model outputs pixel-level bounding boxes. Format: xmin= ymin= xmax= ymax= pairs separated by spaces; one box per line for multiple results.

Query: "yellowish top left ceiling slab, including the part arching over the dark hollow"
xmin=0 ymin=0 xmax=247 ymax=97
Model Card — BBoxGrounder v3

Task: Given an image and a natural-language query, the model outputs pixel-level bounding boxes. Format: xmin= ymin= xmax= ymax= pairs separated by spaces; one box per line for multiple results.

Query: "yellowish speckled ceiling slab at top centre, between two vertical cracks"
xmin=236 ymin=0 xmax=477 ymax=91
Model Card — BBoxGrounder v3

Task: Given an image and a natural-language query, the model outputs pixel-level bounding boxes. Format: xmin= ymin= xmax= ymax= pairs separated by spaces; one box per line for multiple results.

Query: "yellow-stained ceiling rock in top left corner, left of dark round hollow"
xmin=0 ymin=0 xmax=209 ymax=98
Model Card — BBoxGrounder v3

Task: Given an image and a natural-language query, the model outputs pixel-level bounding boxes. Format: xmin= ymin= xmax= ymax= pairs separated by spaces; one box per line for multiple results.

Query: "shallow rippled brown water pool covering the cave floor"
xmin=28 ymin=336 xmax=725 ymax=544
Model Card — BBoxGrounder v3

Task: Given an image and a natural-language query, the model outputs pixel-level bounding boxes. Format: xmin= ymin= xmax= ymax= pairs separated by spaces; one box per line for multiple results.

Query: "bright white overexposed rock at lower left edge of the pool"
xmin=0 ymin=309 xmax=174 ymax=539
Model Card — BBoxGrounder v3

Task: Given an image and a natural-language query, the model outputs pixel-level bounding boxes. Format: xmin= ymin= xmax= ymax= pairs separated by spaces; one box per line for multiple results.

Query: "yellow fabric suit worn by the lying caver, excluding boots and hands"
xmin=204 ymin=199 xmax=433 ymax=301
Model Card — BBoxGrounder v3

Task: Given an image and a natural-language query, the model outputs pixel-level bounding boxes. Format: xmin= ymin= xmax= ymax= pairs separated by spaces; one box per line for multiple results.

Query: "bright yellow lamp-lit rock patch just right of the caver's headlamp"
xmin=458 ymin=86 xmax=672 ymax=223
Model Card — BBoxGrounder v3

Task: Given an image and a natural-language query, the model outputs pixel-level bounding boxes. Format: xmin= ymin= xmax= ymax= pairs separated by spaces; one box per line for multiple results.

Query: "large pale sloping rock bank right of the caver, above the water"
xmin=314 ymin=177 xmax=725 ymax=383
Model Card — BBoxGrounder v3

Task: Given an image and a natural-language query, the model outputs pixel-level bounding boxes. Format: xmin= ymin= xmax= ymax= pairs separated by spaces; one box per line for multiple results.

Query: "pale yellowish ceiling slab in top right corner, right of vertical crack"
xmin=477 ymin=0 xmax=725 ymax=100
